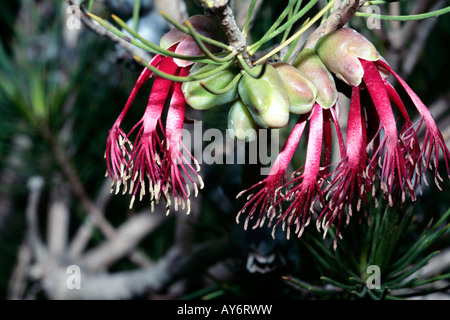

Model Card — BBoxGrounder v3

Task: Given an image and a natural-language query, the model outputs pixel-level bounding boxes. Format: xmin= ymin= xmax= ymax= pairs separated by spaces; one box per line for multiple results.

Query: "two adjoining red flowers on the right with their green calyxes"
xmin=234 ymin=28 xmax=450 ymax=246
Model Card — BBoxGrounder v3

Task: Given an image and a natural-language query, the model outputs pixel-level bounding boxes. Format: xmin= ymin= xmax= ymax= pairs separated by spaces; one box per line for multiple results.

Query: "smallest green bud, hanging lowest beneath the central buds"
xmin=228 ymin=99 xmax=258 ymax=142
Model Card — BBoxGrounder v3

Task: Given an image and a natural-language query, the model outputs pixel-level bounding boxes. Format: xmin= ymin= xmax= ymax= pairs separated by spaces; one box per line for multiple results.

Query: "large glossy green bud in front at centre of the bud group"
xmin=238 ymin=65 xmax=289 ymax=128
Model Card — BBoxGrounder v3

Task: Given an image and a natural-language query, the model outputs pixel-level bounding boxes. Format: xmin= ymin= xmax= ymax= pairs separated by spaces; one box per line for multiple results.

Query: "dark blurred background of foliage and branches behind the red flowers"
xmin=0 ymin=0 xmax=450 ymax=299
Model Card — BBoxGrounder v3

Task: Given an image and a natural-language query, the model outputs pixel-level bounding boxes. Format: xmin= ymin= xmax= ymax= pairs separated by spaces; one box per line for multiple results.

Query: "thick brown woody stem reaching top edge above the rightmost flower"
xmin=304 ymin=0 xmax=365 ymax=49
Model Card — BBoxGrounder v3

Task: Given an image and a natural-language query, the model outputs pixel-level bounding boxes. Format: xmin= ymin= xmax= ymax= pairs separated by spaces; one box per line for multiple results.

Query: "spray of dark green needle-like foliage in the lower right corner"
xmin=287 ymin=201 xmax=450 ymax=300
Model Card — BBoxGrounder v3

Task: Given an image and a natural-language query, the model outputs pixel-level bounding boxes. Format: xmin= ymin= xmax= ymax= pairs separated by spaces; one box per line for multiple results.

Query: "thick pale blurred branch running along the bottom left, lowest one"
xmin=43 ymin=238 xmax=232 ymax=300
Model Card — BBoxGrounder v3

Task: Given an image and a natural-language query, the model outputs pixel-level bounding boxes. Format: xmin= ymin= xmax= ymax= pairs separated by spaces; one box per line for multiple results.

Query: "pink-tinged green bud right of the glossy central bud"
xmin=273 ymin=62 xmax=317 ymax=114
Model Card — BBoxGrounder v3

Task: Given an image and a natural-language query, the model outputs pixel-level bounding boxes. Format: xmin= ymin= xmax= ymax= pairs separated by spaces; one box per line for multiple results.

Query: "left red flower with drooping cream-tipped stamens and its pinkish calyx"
xmin=105 ymin=16 xmax=225 ymax=213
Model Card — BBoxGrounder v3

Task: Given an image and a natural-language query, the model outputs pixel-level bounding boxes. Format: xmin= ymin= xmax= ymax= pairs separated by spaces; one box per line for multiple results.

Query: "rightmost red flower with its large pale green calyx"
xmin=316 ymin=28 xmax=450 ymax=239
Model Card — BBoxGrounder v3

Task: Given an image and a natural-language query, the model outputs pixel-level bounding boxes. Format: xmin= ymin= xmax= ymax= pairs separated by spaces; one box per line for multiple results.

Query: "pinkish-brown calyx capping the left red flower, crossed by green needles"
xmin=159 ymin=15 xmax=226 ymax=67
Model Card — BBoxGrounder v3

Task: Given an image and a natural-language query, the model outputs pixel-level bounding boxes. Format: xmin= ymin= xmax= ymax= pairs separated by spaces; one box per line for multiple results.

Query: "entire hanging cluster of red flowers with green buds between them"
xmin=105 ymin=10 xmax=450 ymax=245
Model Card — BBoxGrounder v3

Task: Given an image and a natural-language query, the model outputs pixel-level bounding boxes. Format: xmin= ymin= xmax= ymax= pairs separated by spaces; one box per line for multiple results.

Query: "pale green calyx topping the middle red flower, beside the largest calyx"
xmin=292 ymin=49 xmax=338 ymax=109
